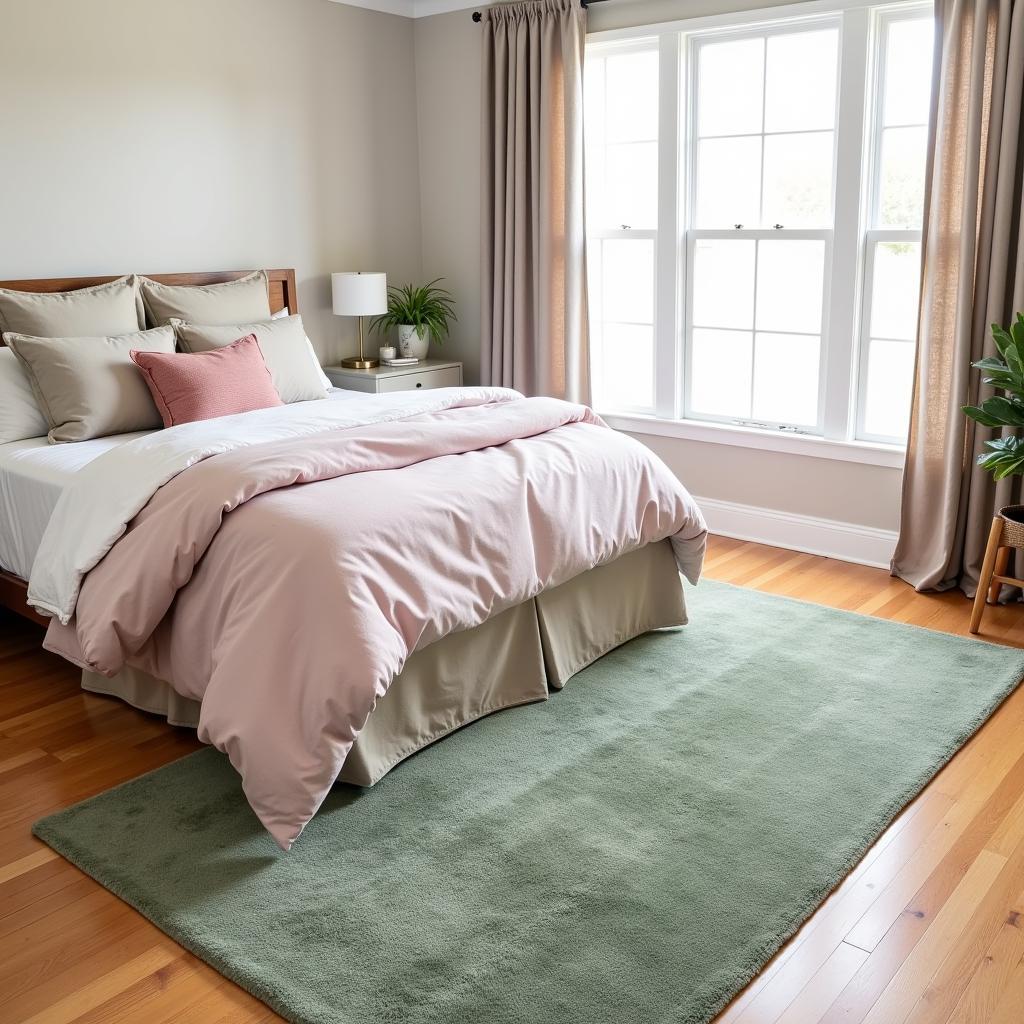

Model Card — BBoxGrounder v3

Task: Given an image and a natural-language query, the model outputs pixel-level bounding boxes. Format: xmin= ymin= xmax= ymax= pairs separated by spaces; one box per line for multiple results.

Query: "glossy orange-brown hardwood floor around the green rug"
xmin=0 ymin=539 xmax=1024 ymax=1024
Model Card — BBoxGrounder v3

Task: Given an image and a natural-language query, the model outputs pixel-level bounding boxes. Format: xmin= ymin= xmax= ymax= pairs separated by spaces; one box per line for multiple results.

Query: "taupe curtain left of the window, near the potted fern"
xmin=480 ymin=0 xmax=590 ymax=402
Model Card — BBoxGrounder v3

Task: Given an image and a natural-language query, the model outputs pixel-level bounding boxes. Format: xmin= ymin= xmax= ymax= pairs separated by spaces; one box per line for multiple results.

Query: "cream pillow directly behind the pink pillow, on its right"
xmin=174 ymin=314 xmax=328 ymax=402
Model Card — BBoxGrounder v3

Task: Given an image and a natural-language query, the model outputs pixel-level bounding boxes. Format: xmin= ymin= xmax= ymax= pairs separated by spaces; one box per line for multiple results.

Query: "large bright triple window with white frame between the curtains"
xmin=586 ymin=2 xmax=932 ymax=443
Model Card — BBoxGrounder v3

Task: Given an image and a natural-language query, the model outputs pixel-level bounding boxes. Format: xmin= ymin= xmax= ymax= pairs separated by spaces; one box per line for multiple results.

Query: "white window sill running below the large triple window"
xmin=600 ymin=413 xmax=906 ymax=469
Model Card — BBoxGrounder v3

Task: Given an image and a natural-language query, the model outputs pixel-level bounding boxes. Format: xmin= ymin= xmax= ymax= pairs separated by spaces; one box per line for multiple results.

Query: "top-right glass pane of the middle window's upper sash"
xmin=765 ymin=29 xmax=839 ymax=131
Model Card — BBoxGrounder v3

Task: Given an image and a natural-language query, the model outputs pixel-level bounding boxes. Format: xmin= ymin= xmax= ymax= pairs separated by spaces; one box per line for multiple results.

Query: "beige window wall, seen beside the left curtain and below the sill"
xmin=407 ymin=0 xmax=902 ymax=529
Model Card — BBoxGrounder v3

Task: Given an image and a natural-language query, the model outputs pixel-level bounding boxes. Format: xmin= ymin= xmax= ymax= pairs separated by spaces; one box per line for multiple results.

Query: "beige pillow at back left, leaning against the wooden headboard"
xmin=0 ymin=275 xmax=145 ymax=338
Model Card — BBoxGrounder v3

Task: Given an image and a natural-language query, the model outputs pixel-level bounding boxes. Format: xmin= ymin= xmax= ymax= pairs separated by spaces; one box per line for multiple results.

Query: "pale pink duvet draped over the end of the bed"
xmin=46 ymin=398 xmax=706 ymax=849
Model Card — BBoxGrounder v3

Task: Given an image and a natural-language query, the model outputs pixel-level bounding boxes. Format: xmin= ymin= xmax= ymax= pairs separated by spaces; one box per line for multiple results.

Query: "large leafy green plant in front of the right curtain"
xmin=964 ymin=313 xmax=1024 ymax=480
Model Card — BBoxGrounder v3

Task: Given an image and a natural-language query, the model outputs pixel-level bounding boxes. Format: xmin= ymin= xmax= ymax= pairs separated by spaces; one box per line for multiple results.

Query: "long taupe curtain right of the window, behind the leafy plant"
xmin=893 ymin=0 xmax=1024 ymax=594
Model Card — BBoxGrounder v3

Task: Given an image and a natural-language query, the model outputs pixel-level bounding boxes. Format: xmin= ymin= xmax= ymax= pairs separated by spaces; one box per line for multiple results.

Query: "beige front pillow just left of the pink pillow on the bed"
xmin=4 ymin=327 xmax=174 ymax=443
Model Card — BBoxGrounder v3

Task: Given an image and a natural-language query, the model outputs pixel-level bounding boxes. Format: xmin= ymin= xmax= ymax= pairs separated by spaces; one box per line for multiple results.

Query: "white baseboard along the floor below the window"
xmin=693 ymin=495 xmax=898 ymax=569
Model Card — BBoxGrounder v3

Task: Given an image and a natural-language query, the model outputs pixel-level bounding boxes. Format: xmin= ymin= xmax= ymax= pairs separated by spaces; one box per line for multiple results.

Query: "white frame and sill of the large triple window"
xmin=588 ymin=0 xmax=931 ymax=467
